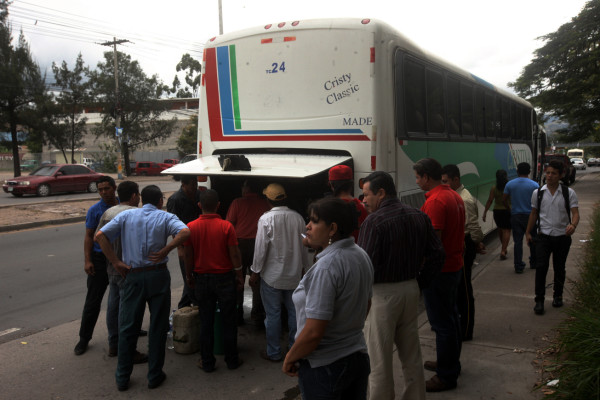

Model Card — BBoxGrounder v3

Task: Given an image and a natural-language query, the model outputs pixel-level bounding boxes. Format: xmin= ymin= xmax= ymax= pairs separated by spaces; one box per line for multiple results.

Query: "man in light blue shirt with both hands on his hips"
xmin=95 ymin=185 xmax=190 ymax=391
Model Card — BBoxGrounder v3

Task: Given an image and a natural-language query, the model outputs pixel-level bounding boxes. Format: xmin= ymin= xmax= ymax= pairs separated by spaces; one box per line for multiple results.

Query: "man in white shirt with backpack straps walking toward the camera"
xmin=525 ymin=161 xmax=579 ymax=315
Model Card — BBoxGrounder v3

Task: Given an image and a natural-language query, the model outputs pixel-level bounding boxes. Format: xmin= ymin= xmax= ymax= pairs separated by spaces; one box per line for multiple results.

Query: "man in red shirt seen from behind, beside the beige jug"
xmin=184 ymin=189 xmax=244 ymax=372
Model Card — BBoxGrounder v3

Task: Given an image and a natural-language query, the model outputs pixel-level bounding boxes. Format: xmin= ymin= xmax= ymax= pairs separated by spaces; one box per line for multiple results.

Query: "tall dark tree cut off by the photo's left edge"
xmin=0 ymin=0 xmax=46 ymax=176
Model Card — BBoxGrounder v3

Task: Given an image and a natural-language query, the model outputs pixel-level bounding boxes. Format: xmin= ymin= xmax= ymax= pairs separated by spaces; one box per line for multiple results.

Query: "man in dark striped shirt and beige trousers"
xmin=358 ymin=171 xmax=444 ymax=399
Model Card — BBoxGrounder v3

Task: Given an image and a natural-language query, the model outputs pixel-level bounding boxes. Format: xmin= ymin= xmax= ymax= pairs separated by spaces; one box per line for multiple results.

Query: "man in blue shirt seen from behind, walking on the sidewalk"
xmin=502 ymin=162 xmax=540 ymax=274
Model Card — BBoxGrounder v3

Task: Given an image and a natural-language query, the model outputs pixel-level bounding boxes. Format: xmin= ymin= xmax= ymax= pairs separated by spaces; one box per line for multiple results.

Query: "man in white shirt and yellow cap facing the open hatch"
xmin=250 ymin=183 xmax=310 ymax=362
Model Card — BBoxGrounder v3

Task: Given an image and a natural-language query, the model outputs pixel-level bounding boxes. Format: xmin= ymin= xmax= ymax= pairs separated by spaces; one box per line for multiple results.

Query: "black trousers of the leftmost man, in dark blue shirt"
xmin=79 ymin=251 xmax=108 ymax=341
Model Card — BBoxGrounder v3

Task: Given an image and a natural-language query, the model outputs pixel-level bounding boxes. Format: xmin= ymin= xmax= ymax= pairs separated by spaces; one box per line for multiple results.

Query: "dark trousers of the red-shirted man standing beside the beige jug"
xmin=194 ymin=271 xmax=238 ymax=369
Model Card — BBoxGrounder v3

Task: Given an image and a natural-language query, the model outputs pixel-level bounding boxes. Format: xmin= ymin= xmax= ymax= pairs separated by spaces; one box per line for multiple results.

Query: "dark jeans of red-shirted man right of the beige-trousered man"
xmin=423 ymin=270 xmax=463 ymax=385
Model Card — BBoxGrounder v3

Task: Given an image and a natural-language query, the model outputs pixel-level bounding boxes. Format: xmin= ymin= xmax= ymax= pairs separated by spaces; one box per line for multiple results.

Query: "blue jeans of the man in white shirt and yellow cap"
xmin=260 ymin=279 xmax=297 ymax=360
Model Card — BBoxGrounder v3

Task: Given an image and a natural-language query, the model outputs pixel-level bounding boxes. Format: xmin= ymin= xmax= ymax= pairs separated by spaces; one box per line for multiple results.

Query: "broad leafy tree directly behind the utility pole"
xmin=89 ymin=52 xmax=176 ymax=175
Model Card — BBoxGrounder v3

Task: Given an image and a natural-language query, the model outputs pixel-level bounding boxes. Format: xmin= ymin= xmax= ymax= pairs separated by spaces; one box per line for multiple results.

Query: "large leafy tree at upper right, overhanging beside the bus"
xmin=509 ymin=0 xmax=600 ymax=142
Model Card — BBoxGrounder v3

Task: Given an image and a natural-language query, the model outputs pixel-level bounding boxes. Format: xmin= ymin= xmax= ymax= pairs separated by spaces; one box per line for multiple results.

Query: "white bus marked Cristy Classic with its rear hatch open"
xmin=164 ymin=19 xmax=541 ymax=231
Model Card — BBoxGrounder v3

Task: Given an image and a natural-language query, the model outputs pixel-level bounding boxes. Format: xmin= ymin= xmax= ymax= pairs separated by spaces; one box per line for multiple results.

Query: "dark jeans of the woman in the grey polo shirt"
xmin=298 ymin=352 xmax=371 ymax=400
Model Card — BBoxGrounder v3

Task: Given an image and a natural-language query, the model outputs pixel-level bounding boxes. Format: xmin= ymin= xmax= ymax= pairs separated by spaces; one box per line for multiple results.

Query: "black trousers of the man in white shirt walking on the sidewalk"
xmin=535 ymin=234 xmax=571 ymax=301
